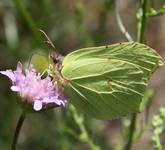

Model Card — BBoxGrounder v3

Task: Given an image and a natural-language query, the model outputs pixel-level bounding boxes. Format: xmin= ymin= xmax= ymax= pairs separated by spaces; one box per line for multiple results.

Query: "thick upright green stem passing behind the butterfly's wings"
xmin=124 ymin=0 xmax=148 ymax=150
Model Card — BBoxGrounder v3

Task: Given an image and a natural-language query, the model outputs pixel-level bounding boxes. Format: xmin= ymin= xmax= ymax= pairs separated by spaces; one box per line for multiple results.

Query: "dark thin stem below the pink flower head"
xmin=11 ymin=111 xmax=25 ymax=150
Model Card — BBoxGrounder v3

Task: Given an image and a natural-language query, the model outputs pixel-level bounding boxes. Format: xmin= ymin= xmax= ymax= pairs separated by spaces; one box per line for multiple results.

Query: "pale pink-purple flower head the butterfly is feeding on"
xmin=0 ymin=62 xmax=66 ymax=111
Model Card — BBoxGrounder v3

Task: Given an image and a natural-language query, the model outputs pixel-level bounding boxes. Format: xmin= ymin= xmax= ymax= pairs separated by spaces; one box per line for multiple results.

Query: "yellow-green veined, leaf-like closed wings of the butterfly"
xmin=61 ymin=42 xmax=163 ymax=119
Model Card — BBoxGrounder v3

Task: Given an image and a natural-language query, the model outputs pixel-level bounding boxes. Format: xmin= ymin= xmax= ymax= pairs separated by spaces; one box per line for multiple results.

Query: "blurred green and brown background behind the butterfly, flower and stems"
xmin=0 ymin=0 xmax=165 ymax=150
